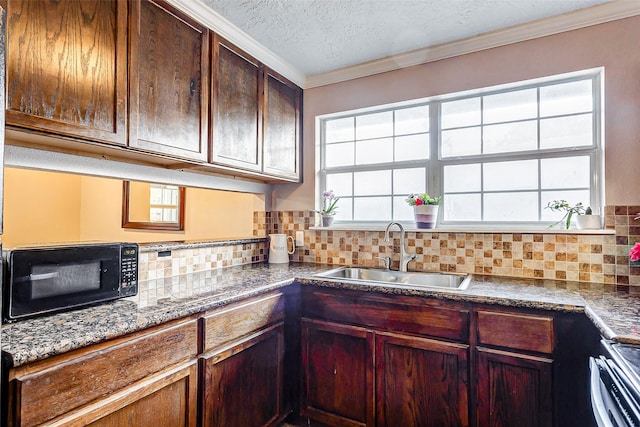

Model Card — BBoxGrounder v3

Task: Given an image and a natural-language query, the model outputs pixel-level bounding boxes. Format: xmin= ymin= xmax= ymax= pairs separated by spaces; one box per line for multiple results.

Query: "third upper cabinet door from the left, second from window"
xmin=211 ymin=35 xmax=262 ymax=172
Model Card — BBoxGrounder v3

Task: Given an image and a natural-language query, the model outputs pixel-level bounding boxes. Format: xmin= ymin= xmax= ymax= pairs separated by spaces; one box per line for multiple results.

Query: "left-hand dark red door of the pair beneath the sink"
xmin=300 ymin=319 xmax=375 ymax=426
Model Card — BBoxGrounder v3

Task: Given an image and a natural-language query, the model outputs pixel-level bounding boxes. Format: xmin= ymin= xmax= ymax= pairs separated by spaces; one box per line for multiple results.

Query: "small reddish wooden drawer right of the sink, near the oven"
xmin=478 ymin=311 xmax=554 ymax=353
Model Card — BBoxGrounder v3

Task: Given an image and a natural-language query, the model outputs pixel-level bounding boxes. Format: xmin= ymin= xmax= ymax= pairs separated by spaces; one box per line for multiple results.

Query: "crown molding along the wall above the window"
xmin=303 ymin=0 xmax=640 ymax=89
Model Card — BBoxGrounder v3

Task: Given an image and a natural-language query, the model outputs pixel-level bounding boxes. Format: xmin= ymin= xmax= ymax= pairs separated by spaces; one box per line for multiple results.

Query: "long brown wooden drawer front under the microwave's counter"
xmin=10 ymin=320 xmax=198 ymax=426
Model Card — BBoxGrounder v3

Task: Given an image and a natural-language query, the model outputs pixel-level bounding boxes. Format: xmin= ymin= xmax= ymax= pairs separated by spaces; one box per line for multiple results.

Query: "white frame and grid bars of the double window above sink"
xmin=318 ymin=70 xmax=602 ymax=226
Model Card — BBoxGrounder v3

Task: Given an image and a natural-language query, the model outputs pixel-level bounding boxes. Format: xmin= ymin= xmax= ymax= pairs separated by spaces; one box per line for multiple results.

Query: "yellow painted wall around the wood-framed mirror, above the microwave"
xmin=2 ymin=168 xmax=265 ymax=247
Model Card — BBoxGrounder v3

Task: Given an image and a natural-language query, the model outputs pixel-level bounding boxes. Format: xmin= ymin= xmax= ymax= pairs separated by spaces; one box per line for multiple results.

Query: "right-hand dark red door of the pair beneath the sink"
xmin=376 ymin=333 xmax=470 ymax=427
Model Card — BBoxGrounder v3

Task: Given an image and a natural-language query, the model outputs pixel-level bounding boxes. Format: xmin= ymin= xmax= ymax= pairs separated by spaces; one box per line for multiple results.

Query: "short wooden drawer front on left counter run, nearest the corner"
xmin=202 ymin=292 xmax=285 ymax=352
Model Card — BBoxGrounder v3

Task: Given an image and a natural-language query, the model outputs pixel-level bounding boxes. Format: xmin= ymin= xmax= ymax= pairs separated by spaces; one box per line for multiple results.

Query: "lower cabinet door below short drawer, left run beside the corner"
xmin=201 ymin=322 xmax=286 ymax=427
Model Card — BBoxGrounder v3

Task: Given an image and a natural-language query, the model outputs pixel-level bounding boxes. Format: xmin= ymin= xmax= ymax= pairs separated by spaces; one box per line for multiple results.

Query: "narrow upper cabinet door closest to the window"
xmin=262 ymin=71 xmax=302 ymax=181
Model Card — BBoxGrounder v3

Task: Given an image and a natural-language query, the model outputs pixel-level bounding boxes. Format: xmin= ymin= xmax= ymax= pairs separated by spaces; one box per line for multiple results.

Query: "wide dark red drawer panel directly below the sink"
xmin=302 ymin=287 xmax=470 ymax=342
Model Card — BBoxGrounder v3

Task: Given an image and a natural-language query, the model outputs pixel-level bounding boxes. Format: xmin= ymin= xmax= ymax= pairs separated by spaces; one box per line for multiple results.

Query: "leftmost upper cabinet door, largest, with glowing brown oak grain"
xmin=6 ymin=0 xmax=127 ymax=144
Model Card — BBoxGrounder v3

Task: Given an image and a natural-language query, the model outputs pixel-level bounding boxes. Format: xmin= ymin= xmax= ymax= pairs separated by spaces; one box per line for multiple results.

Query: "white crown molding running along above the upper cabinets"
xmin=167 ymin=0 xmax=305 ymax=87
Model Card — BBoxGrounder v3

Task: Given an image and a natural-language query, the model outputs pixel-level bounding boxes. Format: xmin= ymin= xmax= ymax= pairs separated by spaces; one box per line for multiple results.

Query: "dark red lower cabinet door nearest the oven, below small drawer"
xmin=477 ymin=348 xmax=553 ymax=427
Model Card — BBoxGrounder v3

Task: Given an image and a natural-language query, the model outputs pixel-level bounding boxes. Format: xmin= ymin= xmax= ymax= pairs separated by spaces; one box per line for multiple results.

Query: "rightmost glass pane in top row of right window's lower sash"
xmin=540 ymin=156 xmax=591 ymax=189
